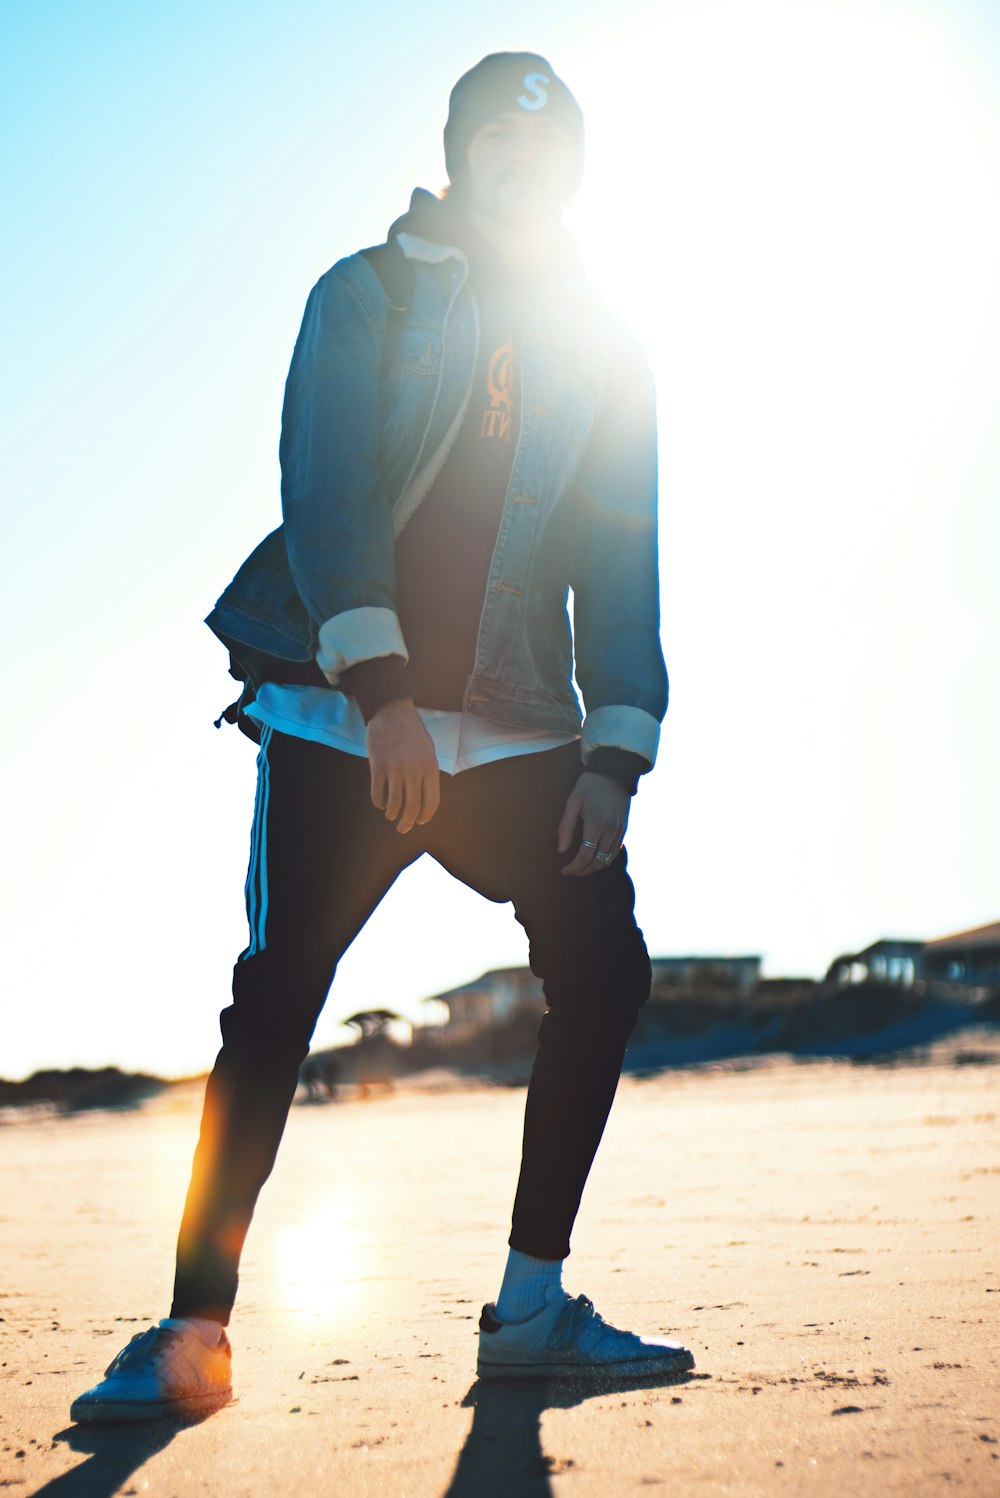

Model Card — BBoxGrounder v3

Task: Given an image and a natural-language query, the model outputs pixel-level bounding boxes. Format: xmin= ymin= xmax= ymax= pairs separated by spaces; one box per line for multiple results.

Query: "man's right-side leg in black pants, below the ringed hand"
xmin=428 ymin=745 xmax=650 ymax=1260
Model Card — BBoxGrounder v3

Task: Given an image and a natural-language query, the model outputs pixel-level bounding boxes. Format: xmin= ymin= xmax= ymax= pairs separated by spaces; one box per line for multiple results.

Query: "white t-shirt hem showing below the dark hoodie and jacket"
xmin=246 ymin=682 xmax=579 ymax=774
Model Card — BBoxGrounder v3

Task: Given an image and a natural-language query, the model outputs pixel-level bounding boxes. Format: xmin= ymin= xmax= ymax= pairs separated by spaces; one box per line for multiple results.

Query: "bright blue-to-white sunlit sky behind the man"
xmin=0 ymin=0 xmax=1000 ymax=1077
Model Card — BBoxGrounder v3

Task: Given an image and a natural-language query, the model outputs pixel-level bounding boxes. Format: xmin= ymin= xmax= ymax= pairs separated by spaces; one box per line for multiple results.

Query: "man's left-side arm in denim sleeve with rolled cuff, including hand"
xmin=280 ymin=257 xmax=440 ymax=833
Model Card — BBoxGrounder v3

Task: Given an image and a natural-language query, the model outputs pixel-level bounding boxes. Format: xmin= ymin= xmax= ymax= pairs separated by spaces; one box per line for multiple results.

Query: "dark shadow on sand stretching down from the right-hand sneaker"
xmin=443 ymin=1374 xmax=694 ymax=1498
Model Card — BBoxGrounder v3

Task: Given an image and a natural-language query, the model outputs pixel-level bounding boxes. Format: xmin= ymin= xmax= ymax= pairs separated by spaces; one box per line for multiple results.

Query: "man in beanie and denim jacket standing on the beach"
xmin=72 ymin=52 xmax=693 ymax=1420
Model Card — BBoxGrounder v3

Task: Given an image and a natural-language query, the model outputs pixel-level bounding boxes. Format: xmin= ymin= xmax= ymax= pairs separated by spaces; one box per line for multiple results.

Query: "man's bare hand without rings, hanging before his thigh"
xmin=365 ymin=697 xmax=442 ymax=833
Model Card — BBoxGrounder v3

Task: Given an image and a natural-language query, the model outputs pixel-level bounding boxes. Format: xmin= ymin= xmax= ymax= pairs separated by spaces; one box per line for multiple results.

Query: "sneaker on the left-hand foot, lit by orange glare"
xmin=69 ymin=1317 xmax=232 ymax=1422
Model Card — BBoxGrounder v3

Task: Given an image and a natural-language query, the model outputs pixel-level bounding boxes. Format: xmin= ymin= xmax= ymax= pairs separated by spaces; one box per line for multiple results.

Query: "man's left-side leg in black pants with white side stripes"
xmin=171 ymin=728 xmax=421 ymax=1324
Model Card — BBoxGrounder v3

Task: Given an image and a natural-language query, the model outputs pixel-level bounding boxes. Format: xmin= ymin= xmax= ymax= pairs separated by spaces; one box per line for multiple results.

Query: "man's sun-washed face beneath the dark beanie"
xmin=467 ymin=109 xmax=576 ymax=225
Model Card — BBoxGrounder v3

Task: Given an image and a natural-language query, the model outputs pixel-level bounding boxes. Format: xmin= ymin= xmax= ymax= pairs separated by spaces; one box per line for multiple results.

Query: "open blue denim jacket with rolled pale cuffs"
xmin=207 ymin=232 xmax=668 ymax=764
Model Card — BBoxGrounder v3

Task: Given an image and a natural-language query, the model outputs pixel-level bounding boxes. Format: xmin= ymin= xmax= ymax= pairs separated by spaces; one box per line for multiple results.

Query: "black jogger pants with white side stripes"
xmin=171 ymin=728 xmax=650 ymax=1323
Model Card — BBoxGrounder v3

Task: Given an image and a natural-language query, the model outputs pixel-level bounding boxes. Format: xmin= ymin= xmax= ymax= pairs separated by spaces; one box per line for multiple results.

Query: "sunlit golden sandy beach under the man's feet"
xmin=0 ymin=1061 xmax=1000 ymax=1498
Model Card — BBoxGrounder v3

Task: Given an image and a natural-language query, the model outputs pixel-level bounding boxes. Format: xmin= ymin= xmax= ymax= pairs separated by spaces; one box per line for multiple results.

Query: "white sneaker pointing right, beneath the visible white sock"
xmin=478 ymin=1287 xmax=695 ymax=1378
